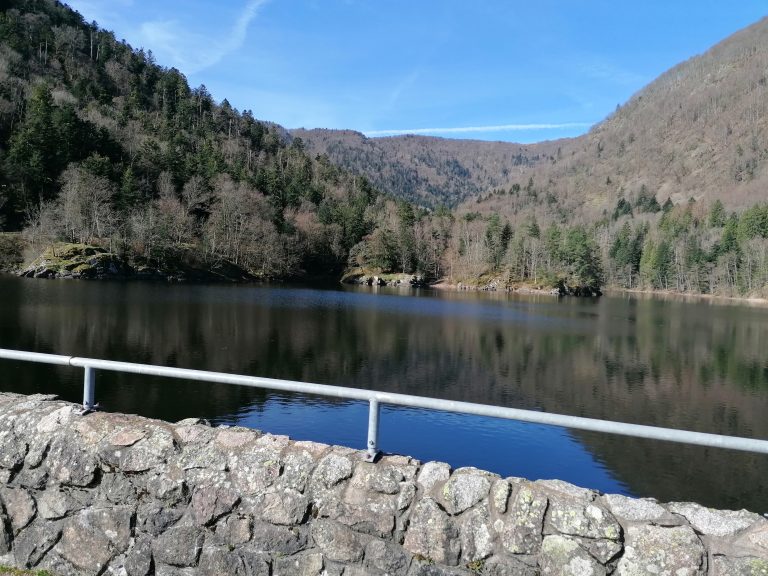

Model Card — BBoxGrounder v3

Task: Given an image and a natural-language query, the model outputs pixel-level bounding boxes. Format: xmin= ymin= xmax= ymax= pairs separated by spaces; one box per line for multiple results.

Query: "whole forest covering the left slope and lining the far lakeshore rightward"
xmin=0 ymin=0 xmax=768 ymax=296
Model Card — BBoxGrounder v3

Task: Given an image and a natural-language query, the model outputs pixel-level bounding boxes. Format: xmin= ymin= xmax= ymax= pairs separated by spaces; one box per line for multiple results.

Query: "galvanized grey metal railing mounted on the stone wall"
xmin=0 ymin=348 xmax=768 ymax=461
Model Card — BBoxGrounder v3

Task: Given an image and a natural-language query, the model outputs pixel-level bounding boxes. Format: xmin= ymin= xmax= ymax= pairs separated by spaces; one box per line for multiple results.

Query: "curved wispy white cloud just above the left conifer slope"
xmin=139 ymin=0 xmax=269 ymax=74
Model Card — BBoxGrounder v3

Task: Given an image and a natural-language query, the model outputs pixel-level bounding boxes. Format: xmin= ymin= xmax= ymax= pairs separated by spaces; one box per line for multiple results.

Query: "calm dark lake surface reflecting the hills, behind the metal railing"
xmin=0 ymin=277 xmax=768 ymax=512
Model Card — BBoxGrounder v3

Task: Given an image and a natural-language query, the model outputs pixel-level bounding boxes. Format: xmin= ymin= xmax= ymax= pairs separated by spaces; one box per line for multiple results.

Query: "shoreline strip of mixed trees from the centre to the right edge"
xmin=350 ymin=188 xmax=768 ymax=297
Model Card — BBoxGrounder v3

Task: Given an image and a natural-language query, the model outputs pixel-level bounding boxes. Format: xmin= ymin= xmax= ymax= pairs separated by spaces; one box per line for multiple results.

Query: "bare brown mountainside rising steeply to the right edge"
xmin=472 ymin=19 xmax=768 ymax=224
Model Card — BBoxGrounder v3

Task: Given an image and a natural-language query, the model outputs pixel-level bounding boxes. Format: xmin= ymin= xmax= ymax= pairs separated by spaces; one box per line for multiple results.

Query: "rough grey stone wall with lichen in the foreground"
xmin=0 ymin=394 xmax=768 ymax=576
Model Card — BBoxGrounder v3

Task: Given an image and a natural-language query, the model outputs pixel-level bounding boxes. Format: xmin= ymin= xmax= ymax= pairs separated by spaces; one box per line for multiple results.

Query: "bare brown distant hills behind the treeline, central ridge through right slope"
xmin=292 ymin=19 xmax=768 ymax=221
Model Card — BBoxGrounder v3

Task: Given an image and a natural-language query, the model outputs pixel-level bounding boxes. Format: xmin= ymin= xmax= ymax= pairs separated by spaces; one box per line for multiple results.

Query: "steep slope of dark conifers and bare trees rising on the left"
xmin=0 ymin=0 xmax=382 ymax=277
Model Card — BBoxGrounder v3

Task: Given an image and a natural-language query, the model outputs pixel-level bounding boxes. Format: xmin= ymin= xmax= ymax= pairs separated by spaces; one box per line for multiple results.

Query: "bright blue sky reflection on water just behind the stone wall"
xmin=230 ymin=393 xmax=631 ymax=494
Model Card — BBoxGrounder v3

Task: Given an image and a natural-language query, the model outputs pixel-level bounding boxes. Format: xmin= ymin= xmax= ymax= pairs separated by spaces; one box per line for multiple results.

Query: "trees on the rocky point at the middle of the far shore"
xmin=350 ymin=202 xmax=605 ymax=287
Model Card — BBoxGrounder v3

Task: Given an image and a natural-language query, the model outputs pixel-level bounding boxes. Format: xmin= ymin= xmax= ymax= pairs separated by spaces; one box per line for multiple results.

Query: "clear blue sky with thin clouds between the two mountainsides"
xmin=68 ymin=0 xmax=768 ymax=142
